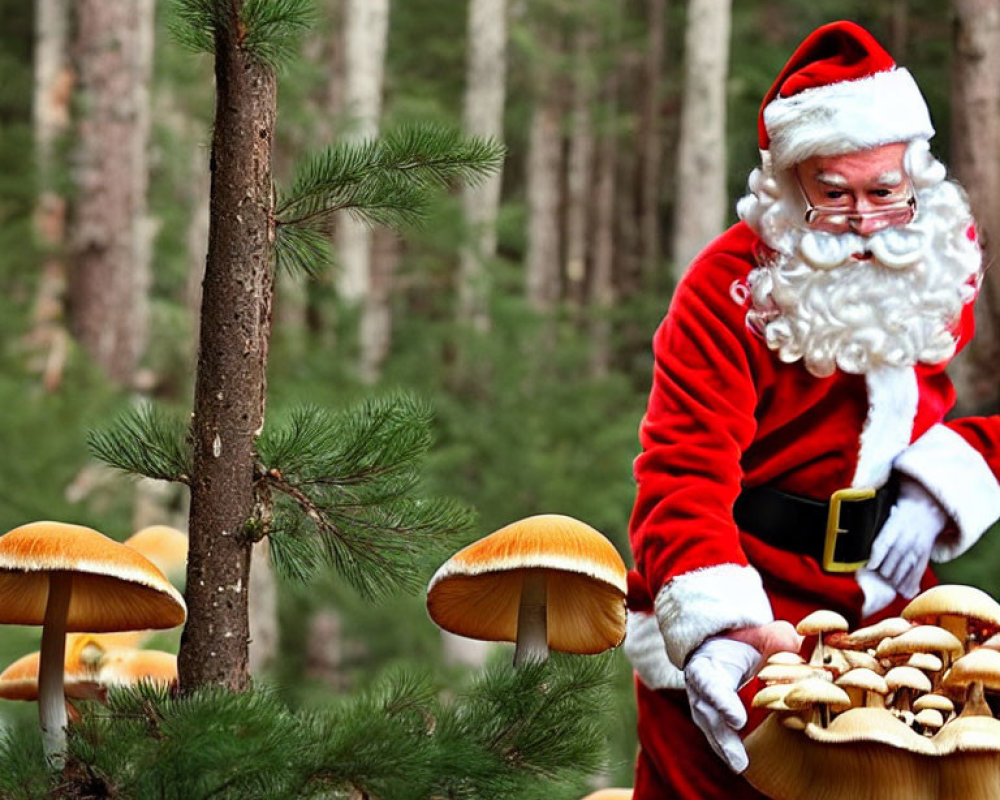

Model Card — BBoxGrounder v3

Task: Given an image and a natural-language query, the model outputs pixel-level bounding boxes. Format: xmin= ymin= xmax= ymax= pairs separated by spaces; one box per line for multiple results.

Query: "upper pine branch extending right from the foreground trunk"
xmin=275 ymin=125 xmax=504 ymax=228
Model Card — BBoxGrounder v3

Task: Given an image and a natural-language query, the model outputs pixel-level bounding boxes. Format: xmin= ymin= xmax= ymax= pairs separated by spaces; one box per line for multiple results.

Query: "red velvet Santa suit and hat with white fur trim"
xmin=625 ymin=23 xmax=1000 ymax=800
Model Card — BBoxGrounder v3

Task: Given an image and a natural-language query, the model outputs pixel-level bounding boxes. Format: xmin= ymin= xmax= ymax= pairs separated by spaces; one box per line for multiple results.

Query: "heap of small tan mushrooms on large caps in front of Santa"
xmin=746 ymin=585 xmax=1000 ymax=800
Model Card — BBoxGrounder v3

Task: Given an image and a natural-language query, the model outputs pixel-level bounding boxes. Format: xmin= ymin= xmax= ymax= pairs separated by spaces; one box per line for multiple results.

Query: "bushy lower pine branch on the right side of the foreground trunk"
xmin=259 ymin=394 xmax=471 ymax=596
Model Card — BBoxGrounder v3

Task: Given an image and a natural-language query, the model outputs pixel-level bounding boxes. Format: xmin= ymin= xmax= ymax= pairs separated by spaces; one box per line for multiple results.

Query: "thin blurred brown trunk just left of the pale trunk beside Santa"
xmin=636 ymin=0 xmax=667 ymax=286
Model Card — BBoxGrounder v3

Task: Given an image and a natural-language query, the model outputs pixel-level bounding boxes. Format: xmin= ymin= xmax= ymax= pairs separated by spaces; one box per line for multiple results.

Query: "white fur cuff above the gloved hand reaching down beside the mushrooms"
xmin=654 ymin=564 xmax=774 ymax=669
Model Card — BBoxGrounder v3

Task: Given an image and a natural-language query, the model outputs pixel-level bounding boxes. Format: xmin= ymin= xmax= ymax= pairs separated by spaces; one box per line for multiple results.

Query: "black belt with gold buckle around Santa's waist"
xmin=733 ymin=476 xmax=898 ymax=572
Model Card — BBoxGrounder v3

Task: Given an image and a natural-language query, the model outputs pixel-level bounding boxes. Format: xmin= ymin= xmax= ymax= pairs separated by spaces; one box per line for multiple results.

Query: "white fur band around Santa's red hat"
xmin=764 ymin=67 xmax=934 ymax=169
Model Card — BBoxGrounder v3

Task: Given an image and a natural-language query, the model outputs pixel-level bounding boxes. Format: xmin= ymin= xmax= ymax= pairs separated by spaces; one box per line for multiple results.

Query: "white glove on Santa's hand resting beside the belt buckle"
xmin=868 ymin=480 xmax=949 ymax=597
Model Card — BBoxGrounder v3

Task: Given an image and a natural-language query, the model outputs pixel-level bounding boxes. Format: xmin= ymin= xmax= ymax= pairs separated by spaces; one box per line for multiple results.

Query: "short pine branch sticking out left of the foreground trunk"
xmin=87 ymin=403 xmax=191 ymax=484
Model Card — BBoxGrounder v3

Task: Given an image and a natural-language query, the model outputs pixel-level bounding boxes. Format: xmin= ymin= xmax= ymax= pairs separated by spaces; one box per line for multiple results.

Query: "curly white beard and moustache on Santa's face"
xmin=738 ymin=143 xmax=981 ymax=377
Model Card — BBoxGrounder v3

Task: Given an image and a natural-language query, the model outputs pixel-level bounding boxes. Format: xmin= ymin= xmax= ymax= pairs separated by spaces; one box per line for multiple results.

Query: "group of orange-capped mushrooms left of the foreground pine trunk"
xmin=0 ymin=521 xmax=187 ymax=766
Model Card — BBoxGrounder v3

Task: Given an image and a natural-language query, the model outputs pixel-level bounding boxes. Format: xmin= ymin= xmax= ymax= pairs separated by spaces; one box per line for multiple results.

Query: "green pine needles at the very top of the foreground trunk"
xmin=170 ymin=0 xmax=315 ymax=68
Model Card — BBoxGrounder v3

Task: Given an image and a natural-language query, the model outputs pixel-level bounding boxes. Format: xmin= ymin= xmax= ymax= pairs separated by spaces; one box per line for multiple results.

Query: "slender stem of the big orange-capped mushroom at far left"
xmin=38 ymin=572 xmax=73 ymax=769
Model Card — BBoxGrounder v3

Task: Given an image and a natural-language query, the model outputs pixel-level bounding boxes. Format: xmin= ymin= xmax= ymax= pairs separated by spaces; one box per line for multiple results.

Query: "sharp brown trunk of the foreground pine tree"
xmin=178 ymin=2 xmax=277 ymax=691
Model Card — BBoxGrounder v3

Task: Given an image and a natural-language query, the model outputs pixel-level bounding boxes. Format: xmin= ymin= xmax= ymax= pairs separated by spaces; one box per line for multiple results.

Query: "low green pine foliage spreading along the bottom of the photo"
xmin=0 ymin=657 xmax=610 ymax=800
